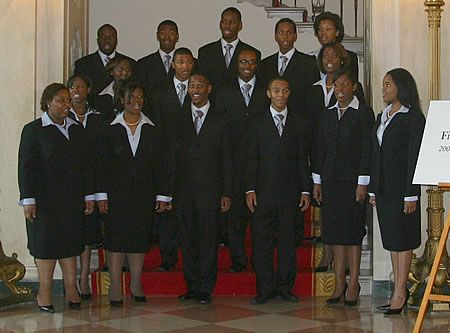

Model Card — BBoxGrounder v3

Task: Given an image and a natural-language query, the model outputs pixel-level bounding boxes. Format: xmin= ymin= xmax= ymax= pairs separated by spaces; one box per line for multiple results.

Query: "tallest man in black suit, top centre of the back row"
xmin=198 ymin=7 xmax=261 ymax=91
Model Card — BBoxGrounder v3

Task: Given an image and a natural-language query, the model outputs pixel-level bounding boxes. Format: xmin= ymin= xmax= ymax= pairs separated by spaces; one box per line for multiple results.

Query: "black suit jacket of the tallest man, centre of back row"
xmin=198 ymin=39 xmax=261 ymax=91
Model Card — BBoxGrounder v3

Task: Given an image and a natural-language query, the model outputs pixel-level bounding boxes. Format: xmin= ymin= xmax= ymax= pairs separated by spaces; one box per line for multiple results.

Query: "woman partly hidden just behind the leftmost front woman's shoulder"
xmin=67 ymin=74 xmax=102 ymax=299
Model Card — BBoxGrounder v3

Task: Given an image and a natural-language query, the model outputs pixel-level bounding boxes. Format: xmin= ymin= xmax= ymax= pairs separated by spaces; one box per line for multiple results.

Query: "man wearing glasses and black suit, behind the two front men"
xmin=216 ymin=49 xmax=269 ymax=273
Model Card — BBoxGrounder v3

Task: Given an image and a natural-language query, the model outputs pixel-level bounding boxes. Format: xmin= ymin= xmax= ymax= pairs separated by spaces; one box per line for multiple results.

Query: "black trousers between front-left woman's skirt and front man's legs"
xmin=155 ymin=210 xmax=179 ymax=266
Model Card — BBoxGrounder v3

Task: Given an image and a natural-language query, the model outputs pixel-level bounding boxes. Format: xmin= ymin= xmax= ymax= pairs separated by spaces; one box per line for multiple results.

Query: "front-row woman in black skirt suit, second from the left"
xmin=96 ymin=81 xmax=171 ymax=306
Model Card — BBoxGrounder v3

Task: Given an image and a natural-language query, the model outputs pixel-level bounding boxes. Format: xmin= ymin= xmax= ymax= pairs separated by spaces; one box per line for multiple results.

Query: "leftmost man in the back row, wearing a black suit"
xmin=74 ymin=24 xmax=136 ymax=96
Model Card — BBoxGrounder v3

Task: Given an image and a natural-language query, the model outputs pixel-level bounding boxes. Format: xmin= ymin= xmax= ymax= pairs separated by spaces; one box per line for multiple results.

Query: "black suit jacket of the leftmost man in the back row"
xmin=74 ymin=51 xmax=136 ymax=96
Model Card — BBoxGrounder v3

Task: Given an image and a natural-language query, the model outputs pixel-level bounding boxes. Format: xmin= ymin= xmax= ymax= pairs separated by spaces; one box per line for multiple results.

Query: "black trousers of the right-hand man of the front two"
xmin=252 ymin=203 xmax=299 ymax=297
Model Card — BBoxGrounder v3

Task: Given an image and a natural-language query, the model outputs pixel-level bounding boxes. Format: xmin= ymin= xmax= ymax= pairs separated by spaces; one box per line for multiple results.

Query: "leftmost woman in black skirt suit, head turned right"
xmin=18 ymin=83 xmax=94 ymax=312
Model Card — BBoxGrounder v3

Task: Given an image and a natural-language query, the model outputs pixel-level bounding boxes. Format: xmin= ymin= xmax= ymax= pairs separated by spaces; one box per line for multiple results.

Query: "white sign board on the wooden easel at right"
xmin=413 ymin=101 xmax=450 ymax=185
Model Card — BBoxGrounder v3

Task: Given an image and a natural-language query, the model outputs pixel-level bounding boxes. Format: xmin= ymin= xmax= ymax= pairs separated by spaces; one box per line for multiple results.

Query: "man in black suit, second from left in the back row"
xmin=137 ymin=20 xmax=179 ymax=96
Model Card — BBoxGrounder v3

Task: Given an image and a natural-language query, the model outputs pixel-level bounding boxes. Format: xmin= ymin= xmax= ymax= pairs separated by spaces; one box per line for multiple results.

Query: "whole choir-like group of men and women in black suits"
xmin=19 ymin=7 xmax=425 ymax=314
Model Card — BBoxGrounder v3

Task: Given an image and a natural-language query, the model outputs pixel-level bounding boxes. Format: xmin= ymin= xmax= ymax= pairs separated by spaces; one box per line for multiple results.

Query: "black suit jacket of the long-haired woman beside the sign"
xmin=369 ymin=108 xmax=425 ymax=197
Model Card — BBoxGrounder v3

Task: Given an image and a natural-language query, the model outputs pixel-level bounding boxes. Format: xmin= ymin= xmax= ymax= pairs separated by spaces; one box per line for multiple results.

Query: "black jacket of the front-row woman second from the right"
xmin=312 ymin=104 xmax=375 ymax=184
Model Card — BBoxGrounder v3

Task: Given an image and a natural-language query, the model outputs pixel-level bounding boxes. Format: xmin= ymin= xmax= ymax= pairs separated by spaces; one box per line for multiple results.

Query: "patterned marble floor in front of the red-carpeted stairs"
xmin=0 ymin=296 xmax=450 ymax=333
